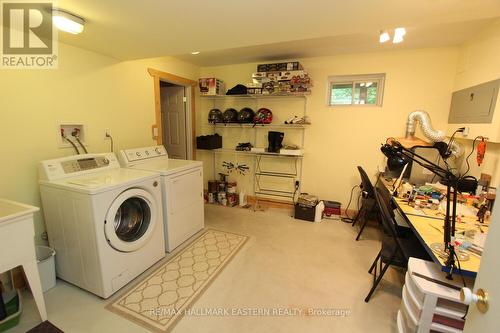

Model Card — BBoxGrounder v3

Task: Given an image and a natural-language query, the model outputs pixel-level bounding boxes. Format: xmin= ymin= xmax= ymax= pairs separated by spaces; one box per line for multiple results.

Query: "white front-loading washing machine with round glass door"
xmin=40 ymin=153 xmax=165 ymax=298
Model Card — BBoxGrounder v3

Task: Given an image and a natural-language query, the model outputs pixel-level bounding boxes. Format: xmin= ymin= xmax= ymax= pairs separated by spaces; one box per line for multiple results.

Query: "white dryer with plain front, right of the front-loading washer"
xmin=118 ymin=146 xmax=205 ymax=252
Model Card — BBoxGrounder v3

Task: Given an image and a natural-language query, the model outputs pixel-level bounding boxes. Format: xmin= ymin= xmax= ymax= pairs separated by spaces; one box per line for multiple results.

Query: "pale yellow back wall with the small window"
xmin=198 ymin=48 xmax=458 ymax=205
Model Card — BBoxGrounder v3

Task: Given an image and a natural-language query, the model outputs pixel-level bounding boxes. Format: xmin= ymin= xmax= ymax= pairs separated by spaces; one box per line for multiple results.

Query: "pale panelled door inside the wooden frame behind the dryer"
xmin=161 ymin=86 xmax=187 ymax=160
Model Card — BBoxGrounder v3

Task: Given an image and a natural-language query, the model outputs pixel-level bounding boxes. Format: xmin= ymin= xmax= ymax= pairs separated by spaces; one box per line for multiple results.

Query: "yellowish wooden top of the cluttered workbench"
xmin=393 ymin=197 xmax=488 ymax=277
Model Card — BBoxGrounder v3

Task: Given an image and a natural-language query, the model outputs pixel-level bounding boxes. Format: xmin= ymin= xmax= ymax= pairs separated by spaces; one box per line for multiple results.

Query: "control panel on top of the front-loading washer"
xmin=40 ymin=153 xmax=120 ymax=180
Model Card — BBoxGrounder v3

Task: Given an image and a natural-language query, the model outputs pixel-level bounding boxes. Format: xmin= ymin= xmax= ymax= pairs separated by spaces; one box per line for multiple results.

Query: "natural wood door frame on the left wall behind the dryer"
xmin=148 ymin=68 xmax=198 ymax=160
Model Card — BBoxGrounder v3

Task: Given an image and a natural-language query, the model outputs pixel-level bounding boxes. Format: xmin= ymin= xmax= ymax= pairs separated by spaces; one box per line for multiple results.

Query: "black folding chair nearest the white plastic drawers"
xmin=365 ymin=187 xmax=432 ymax=302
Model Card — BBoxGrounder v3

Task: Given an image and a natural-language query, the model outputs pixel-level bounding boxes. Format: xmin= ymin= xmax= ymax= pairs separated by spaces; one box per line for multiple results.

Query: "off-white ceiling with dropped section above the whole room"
xmin=58 ymin=0 xmax=500 ymax=66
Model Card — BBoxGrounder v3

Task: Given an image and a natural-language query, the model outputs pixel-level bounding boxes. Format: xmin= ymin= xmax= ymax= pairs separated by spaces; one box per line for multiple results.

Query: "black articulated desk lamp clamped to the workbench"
xmin=380 ymin=140 xmax=460 ymax=280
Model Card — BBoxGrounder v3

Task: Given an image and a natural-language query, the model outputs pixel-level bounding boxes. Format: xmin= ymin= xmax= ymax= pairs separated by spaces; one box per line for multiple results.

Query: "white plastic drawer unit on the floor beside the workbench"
xmin=397 ymin=258 xmax=472 ymax=333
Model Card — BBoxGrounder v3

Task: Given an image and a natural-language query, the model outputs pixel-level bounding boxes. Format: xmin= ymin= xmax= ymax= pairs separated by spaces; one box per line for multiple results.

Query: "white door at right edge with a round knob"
xmin=464 ymin=185 xmax=500 ymax=333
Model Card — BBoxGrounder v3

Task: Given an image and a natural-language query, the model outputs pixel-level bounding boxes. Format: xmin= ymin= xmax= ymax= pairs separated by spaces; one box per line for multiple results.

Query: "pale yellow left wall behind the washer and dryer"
xmin=0 ymin=44 xmax=198 ymax=241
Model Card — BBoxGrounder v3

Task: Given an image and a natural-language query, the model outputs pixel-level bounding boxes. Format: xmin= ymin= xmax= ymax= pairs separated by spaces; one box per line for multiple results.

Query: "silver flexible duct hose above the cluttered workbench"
xmin=406 ymin=110 xmax=463 ymax=157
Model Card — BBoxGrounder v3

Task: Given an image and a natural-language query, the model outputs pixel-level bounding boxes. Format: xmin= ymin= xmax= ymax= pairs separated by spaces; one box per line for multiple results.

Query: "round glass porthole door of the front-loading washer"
xmin=104 ymin=189 xmax=158 ymax=252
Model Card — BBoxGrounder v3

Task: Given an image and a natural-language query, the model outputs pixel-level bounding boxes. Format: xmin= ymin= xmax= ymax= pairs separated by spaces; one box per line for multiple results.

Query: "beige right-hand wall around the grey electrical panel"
xmin=454 ymin=20 xmax=500 ymax=186
